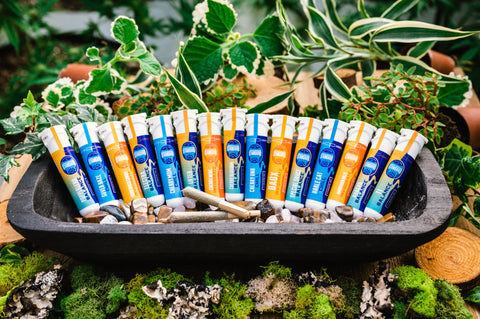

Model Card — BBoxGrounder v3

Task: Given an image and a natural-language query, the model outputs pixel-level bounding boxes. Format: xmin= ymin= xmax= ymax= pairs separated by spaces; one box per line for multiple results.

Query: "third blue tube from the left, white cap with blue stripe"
xmin=245 ymin=114 xmax=271 ymax=203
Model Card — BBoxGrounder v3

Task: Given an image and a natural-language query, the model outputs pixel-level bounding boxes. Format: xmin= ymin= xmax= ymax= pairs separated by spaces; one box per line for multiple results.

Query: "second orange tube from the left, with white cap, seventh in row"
xmin=197 ymin=112 xmax=225 ymax=199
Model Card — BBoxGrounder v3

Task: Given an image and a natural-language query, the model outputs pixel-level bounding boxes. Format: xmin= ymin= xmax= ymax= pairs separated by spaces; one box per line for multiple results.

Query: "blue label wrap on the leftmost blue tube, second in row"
xmin=80 ymin=143 xmax=118 ymax=205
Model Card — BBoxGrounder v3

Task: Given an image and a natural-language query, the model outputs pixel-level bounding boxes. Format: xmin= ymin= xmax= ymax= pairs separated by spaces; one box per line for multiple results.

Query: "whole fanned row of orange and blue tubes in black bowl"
xmin=40 ymin=108 xmax=427 ymax=219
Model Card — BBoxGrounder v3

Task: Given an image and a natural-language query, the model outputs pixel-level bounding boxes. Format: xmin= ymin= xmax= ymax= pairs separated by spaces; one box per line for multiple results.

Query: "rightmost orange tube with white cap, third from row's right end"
xmin=327 ymin=121 xmax=376 ymax=211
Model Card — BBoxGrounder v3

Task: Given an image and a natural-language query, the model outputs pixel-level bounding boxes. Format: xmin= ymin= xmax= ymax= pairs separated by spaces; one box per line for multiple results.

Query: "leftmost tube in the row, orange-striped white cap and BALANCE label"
xmin=38 ymin=125 xmax=100 ymax=216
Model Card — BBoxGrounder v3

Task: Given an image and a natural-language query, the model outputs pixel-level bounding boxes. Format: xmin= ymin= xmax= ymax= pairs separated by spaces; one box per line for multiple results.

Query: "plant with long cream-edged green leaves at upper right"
xmin=279 ymin=0 xmax=477 ymax=114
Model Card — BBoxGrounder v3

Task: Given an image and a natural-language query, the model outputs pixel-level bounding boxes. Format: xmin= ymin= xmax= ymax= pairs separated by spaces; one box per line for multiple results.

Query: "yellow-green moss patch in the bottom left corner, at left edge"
xmin=0 ymin=252 xmax=54 ymax=296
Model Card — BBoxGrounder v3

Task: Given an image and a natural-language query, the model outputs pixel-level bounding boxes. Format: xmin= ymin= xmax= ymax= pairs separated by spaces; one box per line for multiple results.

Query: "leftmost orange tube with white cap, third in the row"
xmin=97 ymin=121 xmax=143 ymax=203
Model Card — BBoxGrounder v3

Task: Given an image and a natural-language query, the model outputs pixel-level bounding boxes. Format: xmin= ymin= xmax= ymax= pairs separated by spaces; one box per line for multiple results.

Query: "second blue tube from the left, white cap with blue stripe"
xmin=147 ymin=115 xmax=184 ymax=208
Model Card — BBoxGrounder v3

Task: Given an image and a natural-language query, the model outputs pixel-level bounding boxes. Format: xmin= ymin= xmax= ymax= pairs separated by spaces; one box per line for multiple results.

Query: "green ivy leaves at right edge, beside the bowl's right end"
xmin=439 ymin=139 xmax=480 ymax=228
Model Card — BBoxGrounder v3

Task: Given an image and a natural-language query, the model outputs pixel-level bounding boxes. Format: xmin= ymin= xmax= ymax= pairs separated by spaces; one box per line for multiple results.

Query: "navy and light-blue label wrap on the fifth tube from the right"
xmin=285 ymin=142 xmax=318 ymax=204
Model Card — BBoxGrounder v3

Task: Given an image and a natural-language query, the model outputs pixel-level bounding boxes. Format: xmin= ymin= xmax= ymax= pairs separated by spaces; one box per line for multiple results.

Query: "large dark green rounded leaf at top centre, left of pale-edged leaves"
xmin=183 ymin=37 xmax=223 ymax=83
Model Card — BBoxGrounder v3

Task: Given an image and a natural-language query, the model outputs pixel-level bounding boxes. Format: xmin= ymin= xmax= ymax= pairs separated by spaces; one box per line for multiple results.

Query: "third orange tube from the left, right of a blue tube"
xmin=265 ymin=115 xmax=297 ymax=208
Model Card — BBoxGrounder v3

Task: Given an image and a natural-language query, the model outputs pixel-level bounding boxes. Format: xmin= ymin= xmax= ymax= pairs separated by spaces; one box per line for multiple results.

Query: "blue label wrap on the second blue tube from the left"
xmin=153 ymin=137 xmax=183 ymax=200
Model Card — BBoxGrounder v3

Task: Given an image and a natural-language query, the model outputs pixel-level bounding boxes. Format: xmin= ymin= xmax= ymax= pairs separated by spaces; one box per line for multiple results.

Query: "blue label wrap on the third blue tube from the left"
xmin=245 ymin=136 xmax=267 ymax=200
